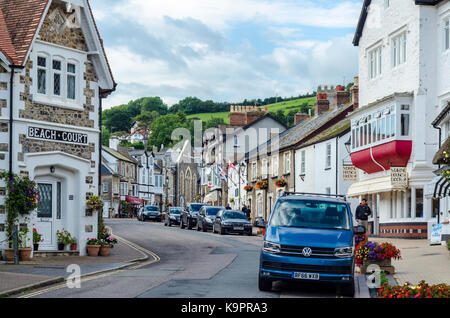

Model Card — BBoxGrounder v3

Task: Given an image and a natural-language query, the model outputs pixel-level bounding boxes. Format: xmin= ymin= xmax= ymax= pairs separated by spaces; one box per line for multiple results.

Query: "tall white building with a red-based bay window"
xmin=348 ymin=0 xmax=450 ymax=238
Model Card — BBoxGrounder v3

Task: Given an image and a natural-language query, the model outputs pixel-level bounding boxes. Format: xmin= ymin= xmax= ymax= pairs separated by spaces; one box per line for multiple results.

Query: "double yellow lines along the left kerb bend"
xmin=18 ymin=235 xmax=161 ymax=298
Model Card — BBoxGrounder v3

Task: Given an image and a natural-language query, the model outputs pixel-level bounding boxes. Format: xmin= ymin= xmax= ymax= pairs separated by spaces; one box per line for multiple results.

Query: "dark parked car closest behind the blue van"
xmin=213 ymin=210 xmax=252 ymax=235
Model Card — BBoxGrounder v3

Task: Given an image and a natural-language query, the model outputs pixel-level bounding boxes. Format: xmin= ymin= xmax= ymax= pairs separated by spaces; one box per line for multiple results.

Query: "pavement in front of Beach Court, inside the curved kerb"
xmin=0 ymin=234 xmax=148 ymax=298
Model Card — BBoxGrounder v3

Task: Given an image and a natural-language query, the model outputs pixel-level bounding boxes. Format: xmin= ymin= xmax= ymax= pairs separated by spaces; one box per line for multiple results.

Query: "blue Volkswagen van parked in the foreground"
xmin=258 ymin=192 xmax=364 ymax=297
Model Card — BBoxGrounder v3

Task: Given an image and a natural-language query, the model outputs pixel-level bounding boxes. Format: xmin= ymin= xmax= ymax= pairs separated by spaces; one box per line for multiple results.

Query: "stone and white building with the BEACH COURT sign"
xmin=0 ymin=0 xmax=116 ymax=255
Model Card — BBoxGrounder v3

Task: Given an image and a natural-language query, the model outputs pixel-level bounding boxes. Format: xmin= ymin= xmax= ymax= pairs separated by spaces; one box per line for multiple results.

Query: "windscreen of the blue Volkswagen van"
xmin=270 ymin=200 xmax=351 ymax=230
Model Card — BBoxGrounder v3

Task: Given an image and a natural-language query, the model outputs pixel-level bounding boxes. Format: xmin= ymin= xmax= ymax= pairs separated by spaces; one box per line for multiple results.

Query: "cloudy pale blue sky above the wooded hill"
xmin=90 ymin=0 xmax=362 ymax=108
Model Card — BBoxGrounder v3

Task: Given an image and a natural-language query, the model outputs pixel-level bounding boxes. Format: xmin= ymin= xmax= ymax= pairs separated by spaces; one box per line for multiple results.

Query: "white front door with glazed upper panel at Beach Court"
xmin=36 ymin=181 xmax=61 ymax=250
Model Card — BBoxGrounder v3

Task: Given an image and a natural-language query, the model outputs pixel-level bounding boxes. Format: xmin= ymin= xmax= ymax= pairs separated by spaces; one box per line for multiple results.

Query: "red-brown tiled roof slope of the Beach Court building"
xmin=0 ymin=0 xmax=50 ymax=65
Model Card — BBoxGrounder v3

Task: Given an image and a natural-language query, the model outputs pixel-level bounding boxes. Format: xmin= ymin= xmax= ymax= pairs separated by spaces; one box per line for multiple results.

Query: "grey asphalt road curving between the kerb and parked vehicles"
xmin=17 ymin=219 xmax=341 ymax=298
